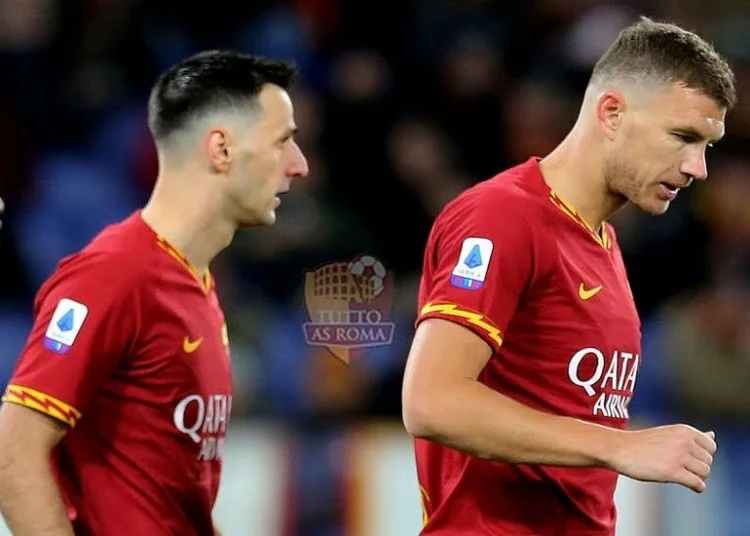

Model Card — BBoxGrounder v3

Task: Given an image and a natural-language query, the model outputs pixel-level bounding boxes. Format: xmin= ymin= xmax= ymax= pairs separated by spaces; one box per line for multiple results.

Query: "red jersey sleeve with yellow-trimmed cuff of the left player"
xmin=3 ymin=255 xmax=135 ymax=426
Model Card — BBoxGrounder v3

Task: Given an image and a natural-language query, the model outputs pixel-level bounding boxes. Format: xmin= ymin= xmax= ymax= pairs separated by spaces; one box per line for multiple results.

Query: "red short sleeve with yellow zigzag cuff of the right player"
xmin=417 ymin=190 xmax=537 ymax=351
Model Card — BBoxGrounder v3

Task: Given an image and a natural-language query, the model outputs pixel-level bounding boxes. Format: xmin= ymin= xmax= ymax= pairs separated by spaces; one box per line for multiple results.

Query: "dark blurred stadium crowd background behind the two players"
xmin=0 ymin=0 xmax=750 ymax=536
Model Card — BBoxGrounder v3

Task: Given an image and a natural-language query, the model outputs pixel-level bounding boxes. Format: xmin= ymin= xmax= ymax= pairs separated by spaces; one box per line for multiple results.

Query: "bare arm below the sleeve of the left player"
xmin=0 ymin=453 xmax=73 ymax=536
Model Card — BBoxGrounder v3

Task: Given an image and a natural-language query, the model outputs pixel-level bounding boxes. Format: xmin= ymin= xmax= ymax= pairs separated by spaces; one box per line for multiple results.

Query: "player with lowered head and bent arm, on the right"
xmin=402 ymin=18 xmax=735 ymax=536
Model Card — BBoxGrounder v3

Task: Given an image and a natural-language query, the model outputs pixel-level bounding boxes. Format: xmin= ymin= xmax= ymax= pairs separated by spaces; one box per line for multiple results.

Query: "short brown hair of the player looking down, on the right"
xmin=591 ymin=17 xmax=737 ymax=109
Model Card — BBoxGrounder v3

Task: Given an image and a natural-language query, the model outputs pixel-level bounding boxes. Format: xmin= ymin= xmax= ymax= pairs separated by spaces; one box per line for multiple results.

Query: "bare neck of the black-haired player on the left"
xmin=141 ymin=175 xmax=237 ymax=273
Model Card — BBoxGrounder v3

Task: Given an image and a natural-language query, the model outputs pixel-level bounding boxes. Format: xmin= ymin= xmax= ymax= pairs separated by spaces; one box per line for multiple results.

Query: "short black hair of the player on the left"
xmin=148 ymin=50 xmax=297 ymax=143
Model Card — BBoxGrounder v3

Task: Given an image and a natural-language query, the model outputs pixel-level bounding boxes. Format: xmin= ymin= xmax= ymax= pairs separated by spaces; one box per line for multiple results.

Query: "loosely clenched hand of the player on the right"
xmin=611 ymin=424 xmax=716 ymax=493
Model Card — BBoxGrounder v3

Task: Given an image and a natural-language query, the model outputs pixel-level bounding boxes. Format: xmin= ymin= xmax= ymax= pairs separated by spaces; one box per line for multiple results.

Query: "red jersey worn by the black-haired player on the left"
xmin=3 ymin=213 xmax=232 ymax=536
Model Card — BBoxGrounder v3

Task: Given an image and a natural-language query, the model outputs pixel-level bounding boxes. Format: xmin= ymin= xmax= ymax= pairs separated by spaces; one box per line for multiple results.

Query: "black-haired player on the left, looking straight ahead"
xmin=0 ymin=51 xmax=307 ymax=536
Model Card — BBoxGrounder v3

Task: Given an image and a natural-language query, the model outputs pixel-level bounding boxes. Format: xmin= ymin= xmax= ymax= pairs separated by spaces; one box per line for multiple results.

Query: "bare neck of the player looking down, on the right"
xmin=539 ymin=128 xmax=625 ymax=232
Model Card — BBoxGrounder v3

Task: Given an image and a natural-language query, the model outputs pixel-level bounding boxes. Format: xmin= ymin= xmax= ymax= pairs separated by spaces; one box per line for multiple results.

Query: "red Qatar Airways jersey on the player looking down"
xmin=416 ymin=159 xmax=641 ymax=536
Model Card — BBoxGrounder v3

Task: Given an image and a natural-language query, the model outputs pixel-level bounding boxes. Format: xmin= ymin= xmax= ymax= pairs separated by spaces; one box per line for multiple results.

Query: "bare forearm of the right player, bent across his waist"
xmin=405 ymin=379 xmax=622 ymax=467
